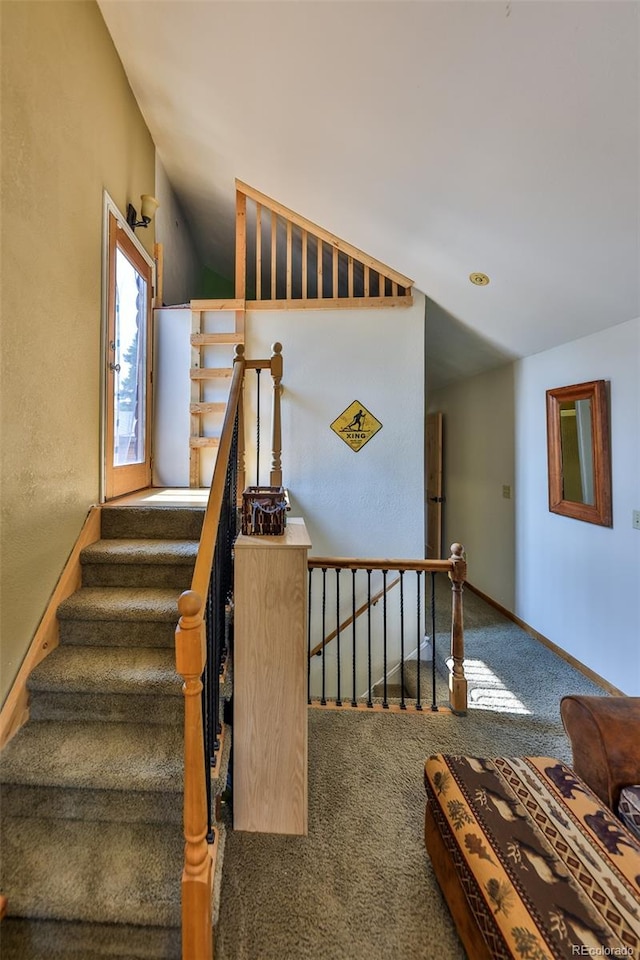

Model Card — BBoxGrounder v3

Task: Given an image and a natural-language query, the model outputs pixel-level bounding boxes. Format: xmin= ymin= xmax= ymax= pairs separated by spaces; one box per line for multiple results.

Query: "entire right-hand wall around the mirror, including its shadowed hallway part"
xmin=429 ymin=320 xmax=640 ymax=696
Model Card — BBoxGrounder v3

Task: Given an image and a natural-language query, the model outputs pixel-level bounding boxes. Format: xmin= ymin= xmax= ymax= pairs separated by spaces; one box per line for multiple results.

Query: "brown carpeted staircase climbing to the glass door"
xmin=0 ymin=506 xmax=230 ymax=960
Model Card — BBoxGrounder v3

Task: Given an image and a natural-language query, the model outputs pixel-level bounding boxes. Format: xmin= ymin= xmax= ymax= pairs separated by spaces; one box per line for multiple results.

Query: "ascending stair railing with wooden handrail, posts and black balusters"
xmin=176 ymin=343 xmax=282 ymax=960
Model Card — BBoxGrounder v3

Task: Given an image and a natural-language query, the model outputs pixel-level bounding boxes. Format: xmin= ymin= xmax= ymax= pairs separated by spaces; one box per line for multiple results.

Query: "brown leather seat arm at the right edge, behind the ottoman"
xmin=560 ymin=695 xmax=640 ymax=813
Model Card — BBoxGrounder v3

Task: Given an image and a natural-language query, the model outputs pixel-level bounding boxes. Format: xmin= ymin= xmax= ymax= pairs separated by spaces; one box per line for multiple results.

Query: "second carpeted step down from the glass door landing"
xmin=80 ymin=539 xmax=198 ymax=590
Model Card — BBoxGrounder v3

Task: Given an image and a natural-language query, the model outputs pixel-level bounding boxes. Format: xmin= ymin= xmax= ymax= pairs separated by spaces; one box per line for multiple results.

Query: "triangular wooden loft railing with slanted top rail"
xmin=236 ymin=180 xmax=413 ymax=310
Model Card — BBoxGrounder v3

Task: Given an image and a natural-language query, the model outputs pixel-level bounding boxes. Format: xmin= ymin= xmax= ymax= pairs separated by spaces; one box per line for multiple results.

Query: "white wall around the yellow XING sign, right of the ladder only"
xmin=247 ymin=293 xmax=424 ymax=557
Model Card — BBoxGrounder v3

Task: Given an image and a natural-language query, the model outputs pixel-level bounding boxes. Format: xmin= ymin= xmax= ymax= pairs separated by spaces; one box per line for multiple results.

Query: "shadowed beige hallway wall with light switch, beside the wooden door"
xmin=428 ymin=364 xmax=518 ymax=610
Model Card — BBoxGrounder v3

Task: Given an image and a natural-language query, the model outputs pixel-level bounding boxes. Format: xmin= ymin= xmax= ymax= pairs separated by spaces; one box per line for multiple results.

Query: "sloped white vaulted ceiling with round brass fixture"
xmin=99 ymin=0 xmax=640 ymax=380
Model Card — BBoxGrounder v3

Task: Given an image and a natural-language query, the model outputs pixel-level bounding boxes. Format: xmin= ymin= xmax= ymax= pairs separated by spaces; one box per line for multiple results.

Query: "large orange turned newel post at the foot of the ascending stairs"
xmin=176 ymin=590 xmax=213 ymax=960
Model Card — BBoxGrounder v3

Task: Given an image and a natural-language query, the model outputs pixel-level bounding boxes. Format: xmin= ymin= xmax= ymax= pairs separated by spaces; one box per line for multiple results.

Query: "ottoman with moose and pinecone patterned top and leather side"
xmin=425 ymin=755 xmax=640 ymax=960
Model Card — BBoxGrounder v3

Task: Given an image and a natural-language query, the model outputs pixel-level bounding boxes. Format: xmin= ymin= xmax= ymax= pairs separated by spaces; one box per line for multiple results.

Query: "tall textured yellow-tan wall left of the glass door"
xmin=0 ymin=0 xmax=155 ymax=699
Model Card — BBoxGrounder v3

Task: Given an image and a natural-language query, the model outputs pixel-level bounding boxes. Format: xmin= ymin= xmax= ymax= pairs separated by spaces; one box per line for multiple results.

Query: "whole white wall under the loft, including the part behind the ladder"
xmin=154 ymin=293 xmax=424 ymax=558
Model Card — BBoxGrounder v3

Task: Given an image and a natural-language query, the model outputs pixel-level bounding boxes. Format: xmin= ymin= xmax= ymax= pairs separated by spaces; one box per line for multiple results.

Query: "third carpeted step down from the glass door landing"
xmin=58 ymin=587 xmax=182 ymax=648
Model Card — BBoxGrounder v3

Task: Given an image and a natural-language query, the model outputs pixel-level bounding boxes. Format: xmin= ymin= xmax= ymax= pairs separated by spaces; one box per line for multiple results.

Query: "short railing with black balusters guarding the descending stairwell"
xmin=308 ymin=543 xmax=467 ymax=714
